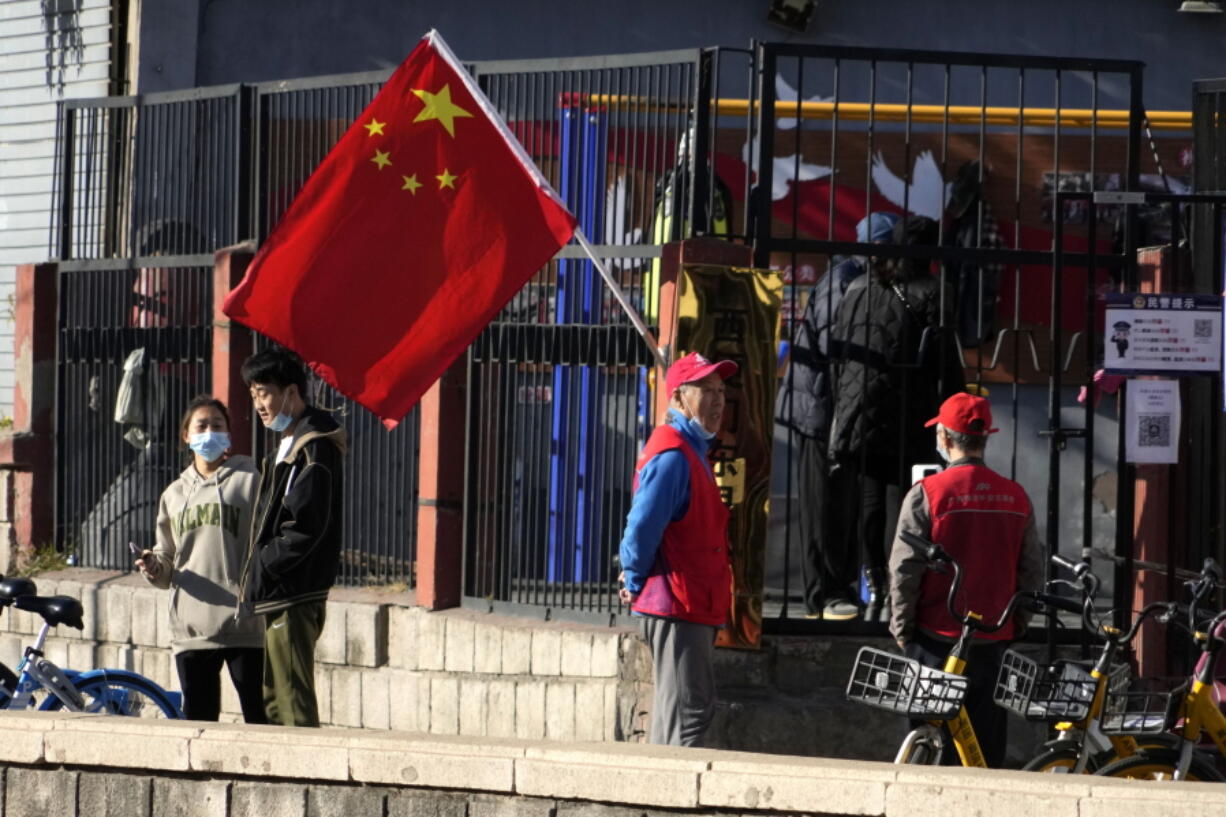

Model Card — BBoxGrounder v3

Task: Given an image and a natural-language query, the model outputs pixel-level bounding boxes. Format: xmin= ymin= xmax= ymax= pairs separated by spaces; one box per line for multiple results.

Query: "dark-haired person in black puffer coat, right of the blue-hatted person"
xmin=828 ymin=216 xmax=965 ymax=621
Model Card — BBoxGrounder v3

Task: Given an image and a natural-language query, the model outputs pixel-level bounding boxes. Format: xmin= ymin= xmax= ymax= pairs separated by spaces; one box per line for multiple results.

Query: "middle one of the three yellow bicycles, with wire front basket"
xmin=993 ymin=554 xmax=1178 ymax=774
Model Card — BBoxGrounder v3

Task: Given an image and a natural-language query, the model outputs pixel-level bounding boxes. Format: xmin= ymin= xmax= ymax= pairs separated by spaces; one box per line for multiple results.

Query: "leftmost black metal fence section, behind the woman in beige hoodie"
xmin=50 ymin=86 xmax=242 ymax=569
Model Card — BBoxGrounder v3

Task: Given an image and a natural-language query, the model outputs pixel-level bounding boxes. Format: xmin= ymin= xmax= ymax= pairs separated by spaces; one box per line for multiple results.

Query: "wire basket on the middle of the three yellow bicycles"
xmin=993 ymin=650 xmax=1128 ymax=721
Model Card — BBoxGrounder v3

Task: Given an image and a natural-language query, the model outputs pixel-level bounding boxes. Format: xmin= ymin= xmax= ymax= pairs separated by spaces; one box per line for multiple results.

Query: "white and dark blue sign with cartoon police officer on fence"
xmin=1103 ymin=293 xmax=1222 ymax=374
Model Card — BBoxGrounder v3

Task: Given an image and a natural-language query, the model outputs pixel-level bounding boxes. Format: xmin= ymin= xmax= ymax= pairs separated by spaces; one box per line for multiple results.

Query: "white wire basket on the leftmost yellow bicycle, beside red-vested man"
xmin=847 ymin=646 xmax=966 ymax=720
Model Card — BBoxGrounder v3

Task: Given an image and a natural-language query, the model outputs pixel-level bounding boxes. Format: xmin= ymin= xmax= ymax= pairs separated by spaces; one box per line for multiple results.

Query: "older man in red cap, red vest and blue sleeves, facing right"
xmin=619 ymin=352 xmax=737 ymax=746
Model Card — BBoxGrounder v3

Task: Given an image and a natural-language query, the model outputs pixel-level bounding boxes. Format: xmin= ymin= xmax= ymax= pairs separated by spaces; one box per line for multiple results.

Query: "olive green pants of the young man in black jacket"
xmin=264 ymin=601 xmax=327 ymax=726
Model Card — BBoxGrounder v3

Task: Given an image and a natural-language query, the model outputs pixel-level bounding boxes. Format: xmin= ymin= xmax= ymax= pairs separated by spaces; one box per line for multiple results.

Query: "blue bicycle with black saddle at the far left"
xmin=0 ymin=569 xmax=183 ymax=719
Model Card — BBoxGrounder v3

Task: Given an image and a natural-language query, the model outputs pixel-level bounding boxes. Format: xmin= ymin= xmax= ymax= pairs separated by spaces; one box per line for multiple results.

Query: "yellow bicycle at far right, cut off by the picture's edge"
xmin=1097 ymin=559 xmax=1226 ymax=781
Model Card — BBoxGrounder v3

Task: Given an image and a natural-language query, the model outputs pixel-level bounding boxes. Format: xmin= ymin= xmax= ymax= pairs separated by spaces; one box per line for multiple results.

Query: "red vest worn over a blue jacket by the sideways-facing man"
xmin=631 ymin=424 xmax=732 ymax=627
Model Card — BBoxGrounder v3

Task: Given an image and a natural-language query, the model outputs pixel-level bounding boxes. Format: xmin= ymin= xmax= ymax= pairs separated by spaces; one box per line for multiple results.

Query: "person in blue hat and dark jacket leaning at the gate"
xmin=775 ymin=212 xmax=899 ymax=621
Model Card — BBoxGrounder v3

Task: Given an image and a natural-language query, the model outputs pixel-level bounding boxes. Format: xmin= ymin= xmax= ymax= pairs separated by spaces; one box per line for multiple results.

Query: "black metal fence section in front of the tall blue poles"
xmin=465 ymin=49 xmax=752 ymax=616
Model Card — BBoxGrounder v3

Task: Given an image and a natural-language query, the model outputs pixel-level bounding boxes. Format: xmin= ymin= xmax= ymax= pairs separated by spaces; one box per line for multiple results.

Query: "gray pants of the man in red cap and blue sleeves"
xmin=642 ymin=616 xmax=716 ymax=746
